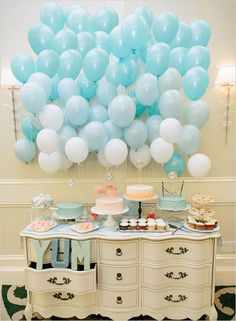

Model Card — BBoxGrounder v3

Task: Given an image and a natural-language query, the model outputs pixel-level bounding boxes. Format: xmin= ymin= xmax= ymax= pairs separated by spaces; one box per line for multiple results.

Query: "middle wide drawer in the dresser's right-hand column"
xmin=141 ymin=264 xmax=212 ymax=287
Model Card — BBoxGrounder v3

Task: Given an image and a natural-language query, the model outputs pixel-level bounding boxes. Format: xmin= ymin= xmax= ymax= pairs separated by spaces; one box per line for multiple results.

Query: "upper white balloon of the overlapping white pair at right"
xmin=160 ymin=118 xmax=182 ymax=144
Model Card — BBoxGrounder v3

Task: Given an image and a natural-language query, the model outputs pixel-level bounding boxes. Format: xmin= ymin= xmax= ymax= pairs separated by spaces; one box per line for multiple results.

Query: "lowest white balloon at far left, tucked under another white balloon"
xmin=38 ymin=152 xmax=61 ymax=174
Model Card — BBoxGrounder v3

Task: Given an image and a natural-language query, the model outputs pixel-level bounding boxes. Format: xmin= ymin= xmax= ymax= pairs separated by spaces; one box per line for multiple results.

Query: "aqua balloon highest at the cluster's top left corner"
xmin=40 ymin=3 xmax=65 ymax=33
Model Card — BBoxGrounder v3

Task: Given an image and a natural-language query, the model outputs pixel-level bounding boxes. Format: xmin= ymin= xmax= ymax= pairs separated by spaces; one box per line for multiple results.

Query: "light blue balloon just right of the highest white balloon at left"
xmin=65 ymin=96 xmax=90 ymax=126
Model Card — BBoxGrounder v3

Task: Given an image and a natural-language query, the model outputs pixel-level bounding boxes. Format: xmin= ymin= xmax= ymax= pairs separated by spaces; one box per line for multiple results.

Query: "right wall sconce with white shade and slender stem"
xmin=215 ymin=65 xmax=236 ymax=145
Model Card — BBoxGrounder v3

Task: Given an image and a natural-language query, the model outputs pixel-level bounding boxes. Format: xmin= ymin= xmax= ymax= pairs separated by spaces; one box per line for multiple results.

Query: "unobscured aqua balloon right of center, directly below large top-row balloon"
xmin=146 ymin=43 xmax=170 ymax=77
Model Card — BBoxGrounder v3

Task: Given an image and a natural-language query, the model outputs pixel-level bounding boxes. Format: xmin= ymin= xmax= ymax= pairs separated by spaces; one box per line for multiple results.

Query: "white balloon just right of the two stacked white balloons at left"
xmin=65 ymin=137 xmax=89 ymax=164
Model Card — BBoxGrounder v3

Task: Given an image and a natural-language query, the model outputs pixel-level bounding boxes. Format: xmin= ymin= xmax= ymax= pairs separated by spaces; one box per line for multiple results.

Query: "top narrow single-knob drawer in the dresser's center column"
xmin=100 ymin=240 xmax=138 ymax=264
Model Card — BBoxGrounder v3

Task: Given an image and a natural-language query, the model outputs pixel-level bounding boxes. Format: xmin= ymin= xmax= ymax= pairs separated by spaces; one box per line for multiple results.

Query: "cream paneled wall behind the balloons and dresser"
xmin=0 ymin=0 xmax=236 ymax=284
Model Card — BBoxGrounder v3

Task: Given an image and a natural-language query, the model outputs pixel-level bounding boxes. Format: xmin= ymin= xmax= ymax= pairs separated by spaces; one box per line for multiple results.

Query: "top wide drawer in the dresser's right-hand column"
xmin=142 ymin=239 xmax=213 ymax=264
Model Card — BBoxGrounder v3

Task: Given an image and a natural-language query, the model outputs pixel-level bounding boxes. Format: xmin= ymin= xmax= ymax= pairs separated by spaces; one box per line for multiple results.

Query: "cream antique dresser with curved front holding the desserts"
xmin=21 ymin=225 xmax=220 ymax=321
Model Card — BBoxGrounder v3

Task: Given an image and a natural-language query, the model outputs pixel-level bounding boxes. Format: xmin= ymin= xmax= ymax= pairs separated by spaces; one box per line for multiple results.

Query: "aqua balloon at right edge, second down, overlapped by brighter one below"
xmin=185 ymin=46 xmax=210 ymax=71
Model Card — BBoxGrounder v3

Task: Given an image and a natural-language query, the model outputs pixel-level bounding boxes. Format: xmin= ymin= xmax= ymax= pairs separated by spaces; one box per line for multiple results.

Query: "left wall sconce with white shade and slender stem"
xmin=1 ymin=69 xmax=21 ymax=141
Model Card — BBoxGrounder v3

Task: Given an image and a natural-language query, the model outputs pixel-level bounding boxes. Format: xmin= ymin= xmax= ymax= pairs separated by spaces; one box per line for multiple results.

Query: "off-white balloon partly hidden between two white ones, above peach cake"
xmin=129 ymin=145 xmax=151 ymax=169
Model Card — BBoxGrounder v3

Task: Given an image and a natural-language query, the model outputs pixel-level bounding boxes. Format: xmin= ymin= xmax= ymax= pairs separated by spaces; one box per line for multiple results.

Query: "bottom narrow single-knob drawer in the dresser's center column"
xmin=101 ymin=289 xmax=139 ymax=310
